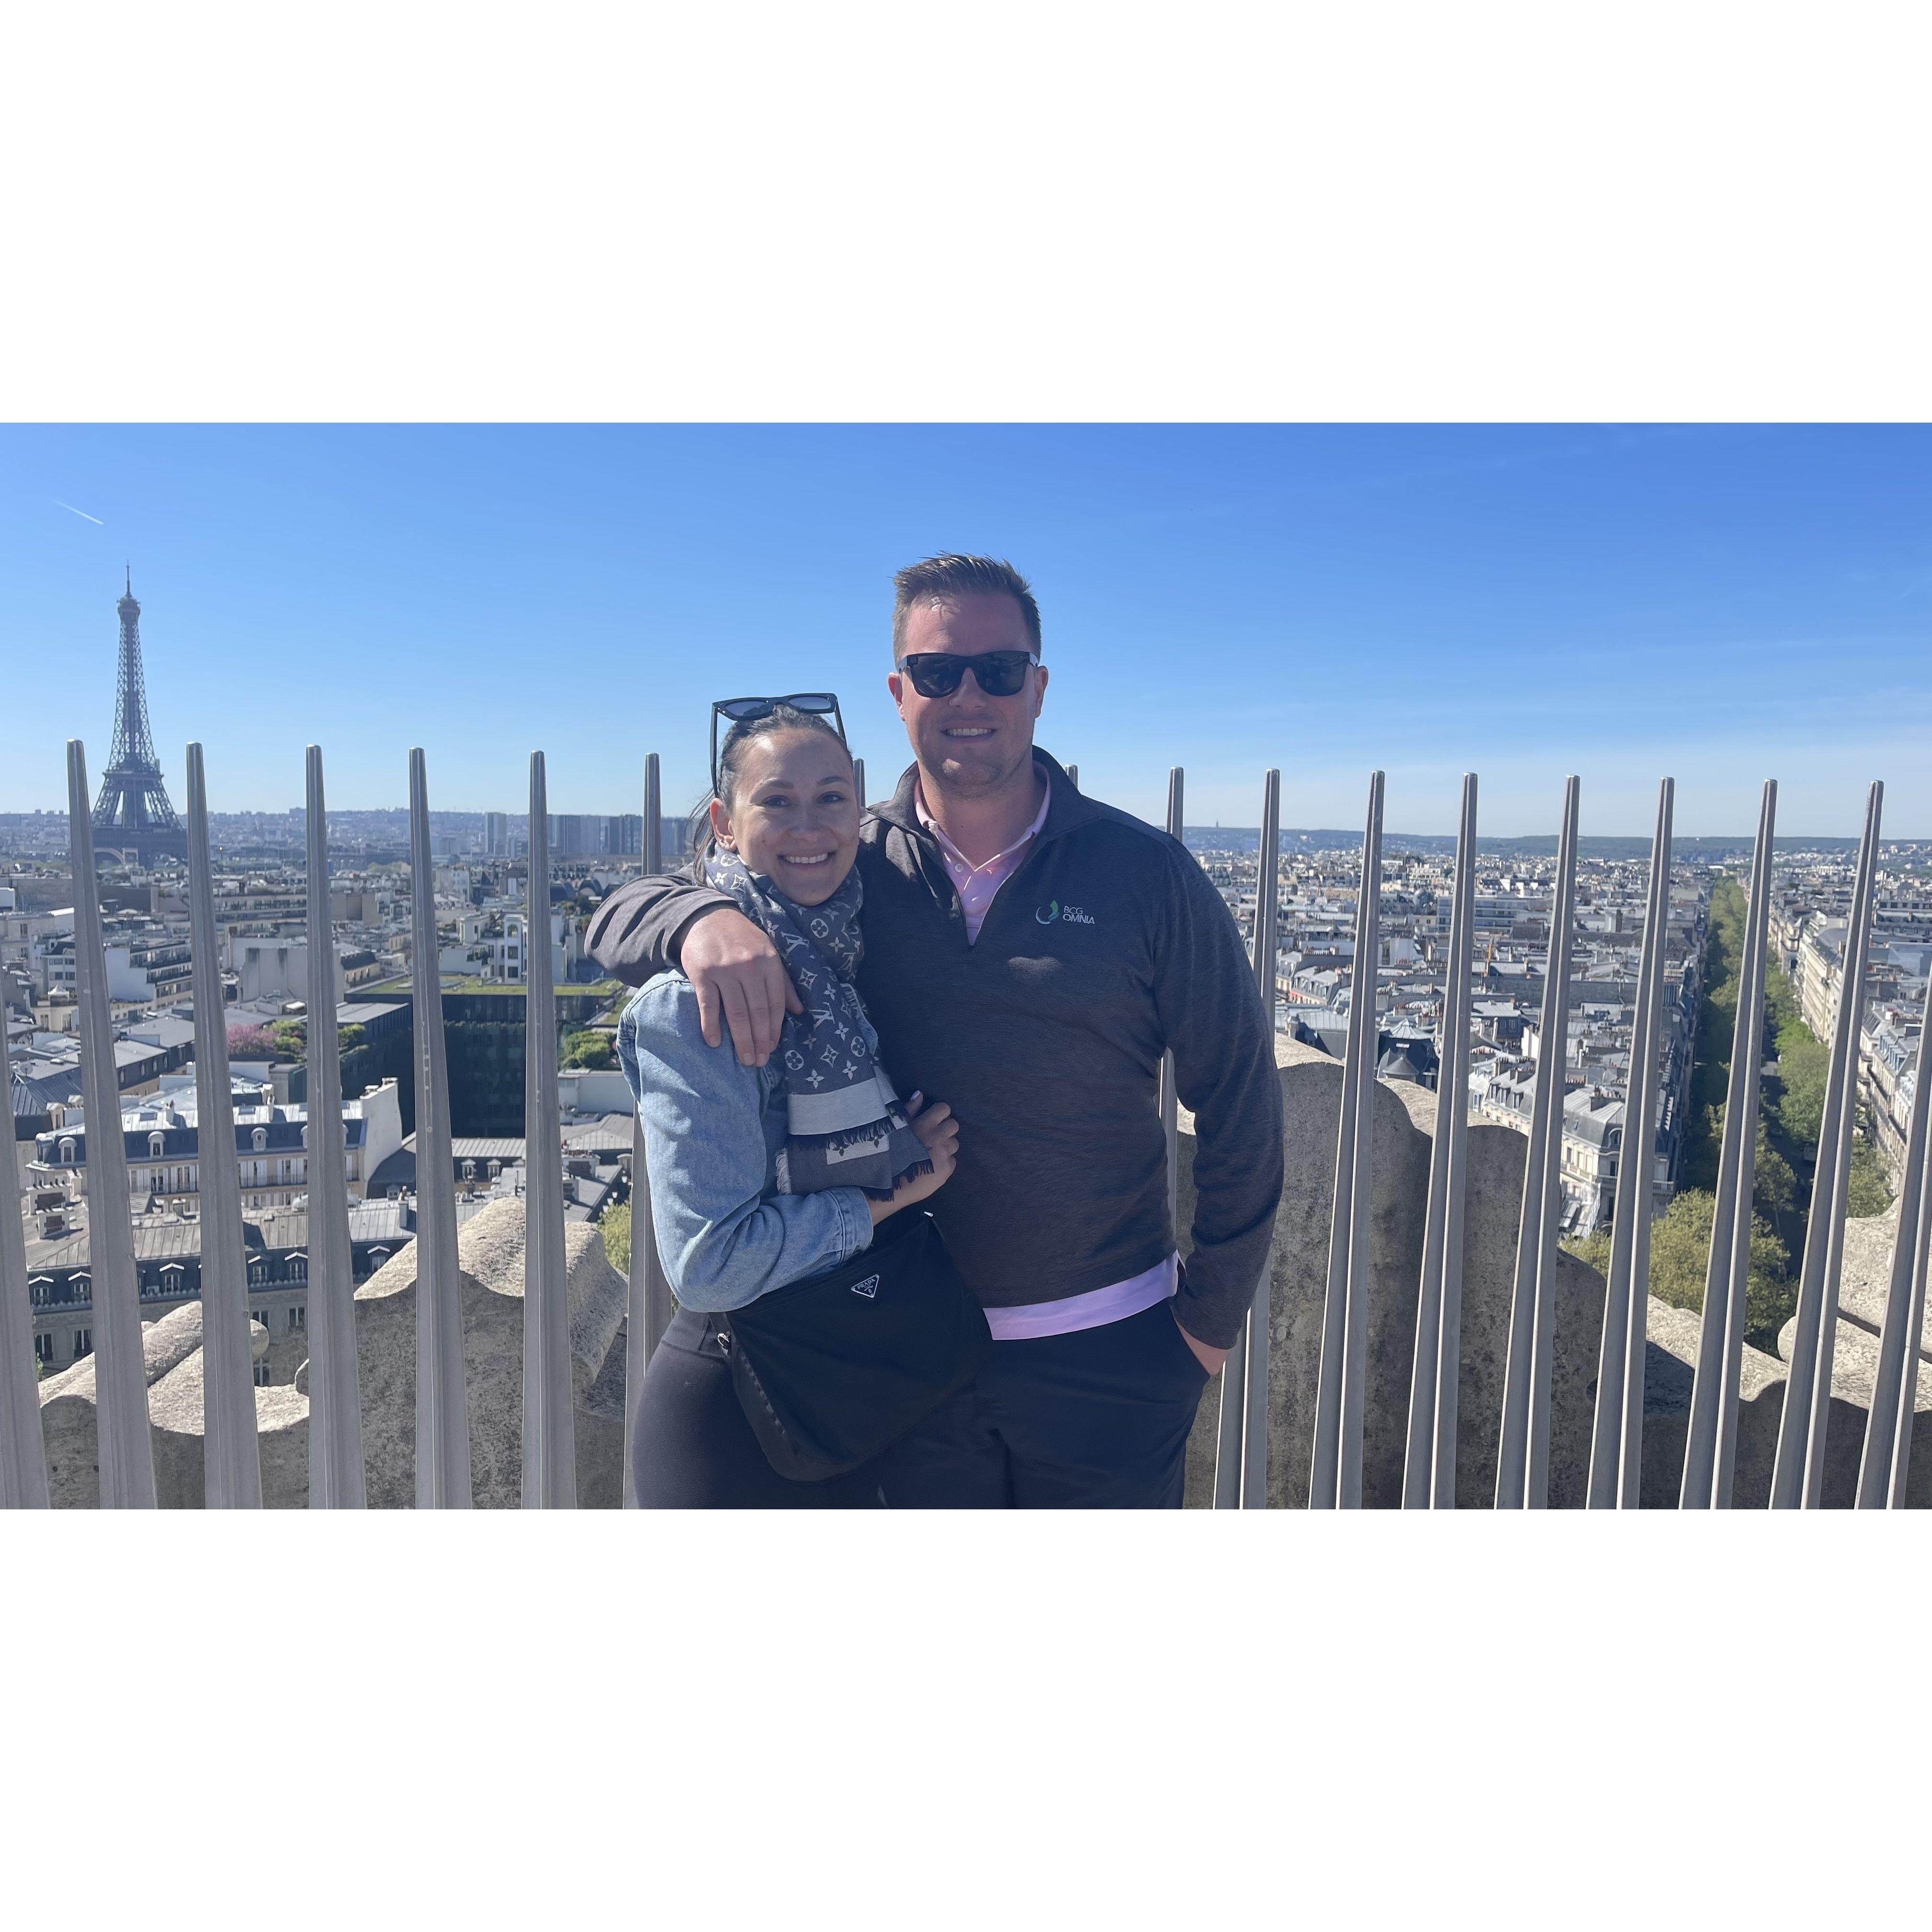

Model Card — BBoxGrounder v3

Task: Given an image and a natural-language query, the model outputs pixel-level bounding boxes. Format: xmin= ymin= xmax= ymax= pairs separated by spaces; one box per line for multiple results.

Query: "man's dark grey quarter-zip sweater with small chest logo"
xmin=589 ymin=748 xmax=1281 ymax=1346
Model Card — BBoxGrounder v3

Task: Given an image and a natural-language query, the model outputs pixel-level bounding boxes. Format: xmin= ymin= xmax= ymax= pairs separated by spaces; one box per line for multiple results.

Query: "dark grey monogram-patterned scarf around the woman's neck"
xmin=705 ymin=850 xmax=933 ymax=1200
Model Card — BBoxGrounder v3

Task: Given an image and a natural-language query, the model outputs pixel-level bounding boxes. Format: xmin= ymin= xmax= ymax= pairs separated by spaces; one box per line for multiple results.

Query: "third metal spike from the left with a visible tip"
xmin=307 ymin=744 xmax=367 ymax=1509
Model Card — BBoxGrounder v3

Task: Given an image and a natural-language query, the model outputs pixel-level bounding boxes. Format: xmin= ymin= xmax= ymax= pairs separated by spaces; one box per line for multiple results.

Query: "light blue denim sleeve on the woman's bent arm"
xmin=618 ymin=974 xmax=871 ymax=1314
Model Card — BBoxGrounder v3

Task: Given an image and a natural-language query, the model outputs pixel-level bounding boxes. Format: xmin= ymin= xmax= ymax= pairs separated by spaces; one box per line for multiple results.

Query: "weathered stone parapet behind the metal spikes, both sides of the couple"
xmin=41 ymin=1041 xmax=1932 ymax=1509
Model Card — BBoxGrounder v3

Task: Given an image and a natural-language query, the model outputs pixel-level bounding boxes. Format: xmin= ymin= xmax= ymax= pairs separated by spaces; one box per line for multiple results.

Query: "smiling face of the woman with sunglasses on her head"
xmin=711 ymin=730 xmax=858 ymax=906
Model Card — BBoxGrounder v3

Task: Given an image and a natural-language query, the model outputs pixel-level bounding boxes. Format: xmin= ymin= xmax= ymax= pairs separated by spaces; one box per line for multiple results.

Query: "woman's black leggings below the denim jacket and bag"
xmin=632 ymin=1308 xmax=881 ymax=1509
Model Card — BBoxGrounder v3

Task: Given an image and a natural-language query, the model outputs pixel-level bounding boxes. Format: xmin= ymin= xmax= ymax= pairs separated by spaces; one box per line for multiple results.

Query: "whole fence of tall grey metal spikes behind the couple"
xmin=0 ymin=742 xmax=1932 ymax=1509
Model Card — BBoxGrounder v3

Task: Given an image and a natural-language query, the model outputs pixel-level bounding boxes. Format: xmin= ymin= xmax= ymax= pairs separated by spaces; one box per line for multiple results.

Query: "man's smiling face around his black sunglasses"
xmin=885 ymin=591 xmax=1047 ymax=794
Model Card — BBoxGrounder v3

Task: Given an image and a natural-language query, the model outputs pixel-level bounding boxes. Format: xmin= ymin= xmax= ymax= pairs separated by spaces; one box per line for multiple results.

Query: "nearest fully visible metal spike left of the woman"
xmin=524 ymin=751 xmax=578 ymax=1509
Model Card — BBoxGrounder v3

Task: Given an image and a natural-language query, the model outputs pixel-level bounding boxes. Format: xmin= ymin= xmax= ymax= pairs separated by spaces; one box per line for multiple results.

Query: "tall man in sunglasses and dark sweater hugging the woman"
xmin=589 ymin=556 xmax=1281 ymax=1507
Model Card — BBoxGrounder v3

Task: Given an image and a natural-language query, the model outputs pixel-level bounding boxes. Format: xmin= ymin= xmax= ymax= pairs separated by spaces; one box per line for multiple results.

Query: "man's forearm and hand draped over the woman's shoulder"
xmin=586 ymin=873 xmax=804 ymax=1067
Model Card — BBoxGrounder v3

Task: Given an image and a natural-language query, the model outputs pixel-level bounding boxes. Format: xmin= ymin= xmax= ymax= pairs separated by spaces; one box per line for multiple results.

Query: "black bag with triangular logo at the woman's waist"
xmin=717 ymin=1208 xmax=993 ymax=1482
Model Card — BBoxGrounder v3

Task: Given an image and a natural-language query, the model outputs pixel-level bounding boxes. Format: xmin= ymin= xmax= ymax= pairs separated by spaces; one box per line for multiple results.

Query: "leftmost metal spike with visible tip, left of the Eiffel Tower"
xmin=68 ymin=738 xmax=155 ymax=1509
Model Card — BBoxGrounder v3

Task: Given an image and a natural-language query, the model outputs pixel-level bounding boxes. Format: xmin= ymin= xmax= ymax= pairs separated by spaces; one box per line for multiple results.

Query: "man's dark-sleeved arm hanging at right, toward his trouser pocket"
xmin=1153 ymin=838 xmax=1281 ymax=1368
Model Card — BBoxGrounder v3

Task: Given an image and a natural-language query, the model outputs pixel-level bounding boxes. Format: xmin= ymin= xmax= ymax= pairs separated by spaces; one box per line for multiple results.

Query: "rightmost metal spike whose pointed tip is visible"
xmin=1771 ymin=784 xmax=1878 ymax=1509
